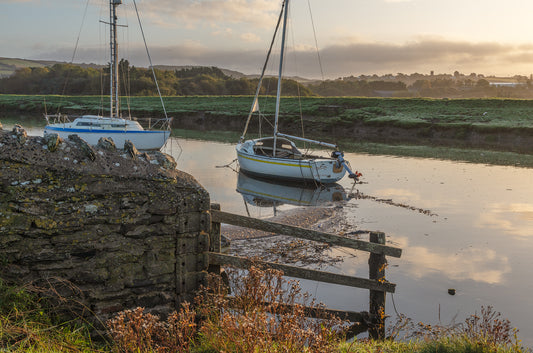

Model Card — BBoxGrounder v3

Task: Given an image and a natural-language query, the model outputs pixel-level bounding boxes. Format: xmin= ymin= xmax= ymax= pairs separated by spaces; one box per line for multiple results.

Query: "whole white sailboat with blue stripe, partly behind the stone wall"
xmin=44 ymin=0 xmax=171 ymax=150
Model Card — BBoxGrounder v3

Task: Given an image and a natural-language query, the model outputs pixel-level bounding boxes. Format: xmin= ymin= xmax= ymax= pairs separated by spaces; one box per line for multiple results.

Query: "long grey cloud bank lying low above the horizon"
xmin=33 ymin=37 xmax=533 ymax=78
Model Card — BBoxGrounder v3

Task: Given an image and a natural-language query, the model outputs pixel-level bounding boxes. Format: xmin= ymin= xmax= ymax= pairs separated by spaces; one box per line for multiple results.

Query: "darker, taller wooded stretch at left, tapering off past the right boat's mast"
xmin=0 ymin=59 xmax=314 ymax=96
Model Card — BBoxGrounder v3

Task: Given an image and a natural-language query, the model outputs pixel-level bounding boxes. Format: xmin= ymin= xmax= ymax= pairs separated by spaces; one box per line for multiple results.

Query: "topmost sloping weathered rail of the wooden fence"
xmin=211 ymin=209 xmax=402 ymax=257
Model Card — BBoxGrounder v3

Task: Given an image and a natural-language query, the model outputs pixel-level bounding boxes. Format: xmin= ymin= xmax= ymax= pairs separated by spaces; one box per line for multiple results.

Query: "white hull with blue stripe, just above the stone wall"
xmin=44 ymin=125 xmax=170 ymax=150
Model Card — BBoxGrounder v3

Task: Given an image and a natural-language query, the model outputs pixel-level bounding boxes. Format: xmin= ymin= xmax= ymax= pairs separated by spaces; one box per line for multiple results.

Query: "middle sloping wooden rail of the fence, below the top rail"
xmin=209 ymin=252 xmax=396 ymax=293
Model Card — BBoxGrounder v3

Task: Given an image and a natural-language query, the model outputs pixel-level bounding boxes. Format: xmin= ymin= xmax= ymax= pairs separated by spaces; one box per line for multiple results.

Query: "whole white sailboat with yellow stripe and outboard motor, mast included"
xmin=236 ymin=0 xmax=360 ymax=183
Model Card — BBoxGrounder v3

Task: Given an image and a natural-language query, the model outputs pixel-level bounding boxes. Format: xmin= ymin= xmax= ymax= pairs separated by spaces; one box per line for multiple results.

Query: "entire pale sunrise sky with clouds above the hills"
xmin=0 ymin=0 xmax=533 ymax=79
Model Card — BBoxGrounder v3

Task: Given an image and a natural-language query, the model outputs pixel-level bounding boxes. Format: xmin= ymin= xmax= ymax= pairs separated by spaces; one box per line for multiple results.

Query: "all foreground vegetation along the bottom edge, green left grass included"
xmin=0 ymin=268 xmax=530 ymax=353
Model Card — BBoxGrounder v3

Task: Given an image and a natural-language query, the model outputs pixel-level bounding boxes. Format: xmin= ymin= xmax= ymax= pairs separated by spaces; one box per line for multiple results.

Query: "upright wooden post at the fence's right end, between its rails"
xmin=368 ymin=232 xmax=387 ymax=340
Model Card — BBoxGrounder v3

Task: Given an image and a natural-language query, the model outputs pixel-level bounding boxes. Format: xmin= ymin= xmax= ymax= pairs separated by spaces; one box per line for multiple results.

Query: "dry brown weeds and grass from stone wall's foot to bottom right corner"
xmin=108 ymin=267 xmax=528 ymax=353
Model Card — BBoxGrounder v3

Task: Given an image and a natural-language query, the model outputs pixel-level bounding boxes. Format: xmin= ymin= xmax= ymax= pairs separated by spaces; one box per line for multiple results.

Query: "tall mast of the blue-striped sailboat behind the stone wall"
xmin=109 ymin=0 xmax=122 ymax=118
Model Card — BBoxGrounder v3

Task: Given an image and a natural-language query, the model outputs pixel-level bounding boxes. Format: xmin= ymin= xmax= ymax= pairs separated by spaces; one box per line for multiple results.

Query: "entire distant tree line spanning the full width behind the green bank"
xmin=0 ymin=59 xmax=533 ymax=98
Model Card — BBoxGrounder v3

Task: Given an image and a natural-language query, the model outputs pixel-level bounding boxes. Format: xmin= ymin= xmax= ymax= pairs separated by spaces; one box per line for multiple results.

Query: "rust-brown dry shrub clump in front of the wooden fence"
xmin=108 ymin=267 xmax=343 ymax=353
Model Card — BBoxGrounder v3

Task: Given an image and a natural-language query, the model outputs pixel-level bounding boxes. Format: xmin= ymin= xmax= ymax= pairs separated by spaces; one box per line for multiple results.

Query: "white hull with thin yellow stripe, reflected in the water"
xmin=236 ymin=144 xmax=346 ymax=184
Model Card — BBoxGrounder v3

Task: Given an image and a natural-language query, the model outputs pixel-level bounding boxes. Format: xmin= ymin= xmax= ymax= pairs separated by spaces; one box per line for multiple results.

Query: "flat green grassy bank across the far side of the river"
xmin=0 ymin=95 xmax=533 ymax=129
